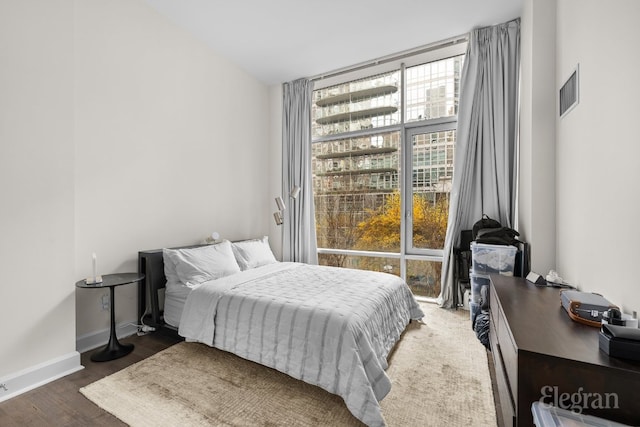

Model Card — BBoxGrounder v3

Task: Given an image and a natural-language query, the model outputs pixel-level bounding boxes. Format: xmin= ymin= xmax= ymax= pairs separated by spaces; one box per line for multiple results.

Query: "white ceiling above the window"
xmin=145 ymin=0 xmax=524 ymax=84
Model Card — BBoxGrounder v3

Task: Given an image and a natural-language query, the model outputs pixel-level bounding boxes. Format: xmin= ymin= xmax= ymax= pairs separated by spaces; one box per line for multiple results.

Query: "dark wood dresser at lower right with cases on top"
xmin=489 ymin=275 xmax=640 ymax=426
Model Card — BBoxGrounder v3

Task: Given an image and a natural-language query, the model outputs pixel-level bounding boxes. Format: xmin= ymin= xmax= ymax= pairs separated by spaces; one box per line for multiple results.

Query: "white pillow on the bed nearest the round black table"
xmin=163 ymin=240 xmax=240 ymax=286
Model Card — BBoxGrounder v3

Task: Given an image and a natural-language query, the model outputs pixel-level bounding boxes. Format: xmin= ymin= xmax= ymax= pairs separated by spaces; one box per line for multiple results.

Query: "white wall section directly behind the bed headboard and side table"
xmin=74 ymin=0 xmax=273 ymax=337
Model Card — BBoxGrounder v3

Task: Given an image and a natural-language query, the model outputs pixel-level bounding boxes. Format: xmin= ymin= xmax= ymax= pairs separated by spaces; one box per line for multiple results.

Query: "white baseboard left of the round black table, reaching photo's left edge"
xmin=0 ymin=351 xmax=84 ymax=402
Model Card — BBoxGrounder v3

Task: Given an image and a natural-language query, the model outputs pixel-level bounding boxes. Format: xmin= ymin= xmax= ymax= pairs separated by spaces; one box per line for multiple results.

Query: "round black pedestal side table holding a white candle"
xmin=76 ymin=273 xmax=144 ymax=362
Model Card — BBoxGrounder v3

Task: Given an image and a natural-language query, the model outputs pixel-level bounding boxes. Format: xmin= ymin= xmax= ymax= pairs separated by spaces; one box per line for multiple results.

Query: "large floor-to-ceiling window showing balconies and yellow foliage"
xmin=312 ymin=47 xmax=464 ymax=297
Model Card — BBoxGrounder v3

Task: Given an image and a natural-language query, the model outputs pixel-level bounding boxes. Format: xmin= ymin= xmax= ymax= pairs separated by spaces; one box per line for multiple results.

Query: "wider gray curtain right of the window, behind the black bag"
xmin=438 ymin=19 xmax=520 ymax=308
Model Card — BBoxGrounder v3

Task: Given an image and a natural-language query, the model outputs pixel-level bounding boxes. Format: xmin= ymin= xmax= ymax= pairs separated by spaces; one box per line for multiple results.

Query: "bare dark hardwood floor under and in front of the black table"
xmin=0 ymin=332 xmax=181 ymax=427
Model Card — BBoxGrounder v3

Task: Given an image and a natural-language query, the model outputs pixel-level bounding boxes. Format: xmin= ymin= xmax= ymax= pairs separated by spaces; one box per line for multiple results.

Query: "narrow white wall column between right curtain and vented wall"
xmin=518 ymin=0 xmax=556 ymax=273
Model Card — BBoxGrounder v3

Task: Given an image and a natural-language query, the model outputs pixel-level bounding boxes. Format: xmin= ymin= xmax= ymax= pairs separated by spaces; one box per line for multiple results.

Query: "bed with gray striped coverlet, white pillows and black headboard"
xmin=139 ymin=237 xmax=423 ymax=426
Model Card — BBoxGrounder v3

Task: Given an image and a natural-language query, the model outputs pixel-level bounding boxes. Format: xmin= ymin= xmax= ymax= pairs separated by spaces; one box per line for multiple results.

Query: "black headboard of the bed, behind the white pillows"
xmin=138 ymin=245 xmax=205 ymax=330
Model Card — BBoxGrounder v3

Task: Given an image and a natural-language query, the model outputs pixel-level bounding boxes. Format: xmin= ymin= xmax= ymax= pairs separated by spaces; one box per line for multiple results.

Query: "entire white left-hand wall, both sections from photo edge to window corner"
xmin=0 ymin=0 xmax=275 ymax=392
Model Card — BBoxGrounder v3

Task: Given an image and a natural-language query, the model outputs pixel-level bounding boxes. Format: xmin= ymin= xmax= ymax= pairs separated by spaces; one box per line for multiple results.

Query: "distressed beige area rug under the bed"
xmin=80 ymin=304 xmax=496 ymax=427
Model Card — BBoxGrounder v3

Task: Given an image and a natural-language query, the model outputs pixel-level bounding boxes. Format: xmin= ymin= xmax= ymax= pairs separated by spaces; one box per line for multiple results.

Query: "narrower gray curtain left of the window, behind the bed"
xmin=282 ymin=79 xmax=318 ymax=264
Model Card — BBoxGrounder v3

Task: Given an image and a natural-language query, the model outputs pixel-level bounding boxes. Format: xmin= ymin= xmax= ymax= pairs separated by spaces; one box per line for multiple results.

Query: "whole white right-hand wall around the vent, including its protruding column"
xmin=520 ymin=0 xmax=640 ymax=313
